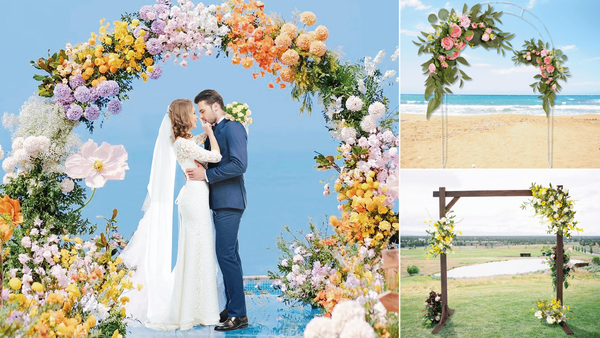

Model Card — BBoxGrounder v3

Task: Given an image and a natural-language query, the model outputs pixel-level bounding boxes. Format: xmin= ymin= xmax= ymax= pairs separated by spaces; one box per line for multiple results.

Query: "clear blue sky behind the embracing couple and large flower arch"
xmin=0 ymin=0 xmax=399 ymax=276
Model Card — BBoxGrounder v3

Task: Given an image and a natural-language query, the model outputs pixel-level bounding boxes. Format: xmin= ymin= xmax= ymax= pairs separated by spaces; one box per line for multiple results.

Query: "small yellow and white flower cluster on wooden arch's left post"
xmin=423 ymin=211 xmax=462 ymax=259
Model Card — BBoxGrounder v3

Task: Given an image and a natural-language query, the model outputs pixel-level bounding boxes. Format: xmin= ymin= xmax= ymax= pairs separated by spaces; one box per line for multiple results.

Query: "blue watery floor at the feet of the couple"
xmin=127 ymin=280 xmax=320 ymax=338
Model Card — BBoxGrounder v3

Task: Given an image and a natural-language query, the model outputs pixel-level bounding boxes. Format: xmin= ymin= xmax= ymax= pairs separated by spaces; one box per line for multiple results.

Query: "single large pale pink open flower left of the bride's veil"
xmin=65 ymin=140 xmax=129 ymax=189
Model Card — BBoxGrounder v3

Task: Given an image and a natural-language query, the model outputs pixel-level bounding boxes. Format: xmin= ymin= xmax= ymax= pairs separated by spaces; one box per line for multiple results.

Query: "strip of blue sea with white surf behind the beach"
xmin=400 ymin=94 xmax=600 ymax=116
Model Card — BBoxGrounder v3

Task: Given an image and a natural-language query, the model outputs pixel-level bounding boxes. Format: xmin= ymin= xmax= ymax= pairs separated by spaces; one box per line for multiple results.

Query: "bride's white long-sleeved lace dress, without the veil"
xmin=146 ymin=137 xmax=221 ymax=330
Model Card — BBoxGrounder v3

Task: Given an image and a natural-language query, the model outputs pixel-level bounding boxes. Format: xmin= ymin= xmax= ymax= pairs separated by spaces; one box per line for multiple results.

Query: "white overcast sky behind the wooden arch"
xmin=400 ymin=169 xmax=600 ymax=236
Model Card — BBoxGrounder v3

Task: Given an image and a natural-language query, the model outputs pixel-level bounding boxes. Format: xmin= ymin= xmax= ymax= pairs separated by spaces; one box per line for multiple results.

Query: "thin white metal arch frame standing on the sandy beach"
xmin=440 ymin=1 xmax=554 ymax=168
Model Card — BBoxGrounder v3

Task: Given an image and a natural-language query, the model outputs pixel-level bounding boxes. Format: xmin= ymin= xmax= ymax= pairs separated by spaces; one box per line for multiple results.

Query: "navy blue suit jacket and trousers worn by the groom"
xmin=204 ymin=119 xmax=248 ymax=317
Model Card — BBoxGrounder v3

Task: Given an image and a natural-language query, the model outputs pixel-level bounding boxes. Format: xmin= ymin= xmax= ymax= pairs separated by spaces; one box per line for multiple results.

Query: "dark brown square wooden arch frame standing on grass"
xmin=431 ymin=185 xmax=573 ymax=335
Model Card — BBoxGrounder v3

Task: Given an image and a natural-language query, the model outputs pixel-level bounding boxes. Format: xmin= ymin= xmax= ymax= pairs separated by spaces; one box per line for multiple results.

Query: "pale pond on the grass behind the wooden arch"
xmin=435 ymin=258 xmax=582 ymax=278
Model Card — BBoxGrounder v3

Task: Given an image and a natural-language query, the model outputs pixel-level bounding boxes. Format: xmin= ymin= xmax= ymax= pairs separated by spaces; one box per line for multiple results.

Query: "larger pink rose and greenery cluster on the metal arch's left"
xmin=413 ymin=4 xmax=514 ymax=119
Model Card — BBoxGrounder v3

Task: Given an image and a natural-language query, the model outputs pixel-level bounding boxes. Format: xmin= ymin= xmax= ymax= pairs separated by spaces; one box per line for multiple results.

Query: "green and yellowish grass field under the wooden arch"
xmin=400 ymin=245 xmax=600 ymax=338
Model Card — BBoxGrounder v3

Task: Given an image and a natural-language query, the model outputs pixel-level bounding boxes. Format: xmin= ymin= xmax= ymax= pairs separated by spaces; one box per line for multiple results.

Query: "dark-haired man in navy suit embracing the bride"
xmin=186 ymin=89 xmax=248 ymax=331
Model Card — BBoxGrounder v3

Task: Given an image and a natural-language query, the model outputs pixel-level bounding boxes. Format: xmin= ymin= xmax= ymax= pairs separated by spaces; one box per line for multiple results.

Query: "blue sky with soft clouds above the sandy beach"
xmin=400 ymin=0 xmax=600 ymax=95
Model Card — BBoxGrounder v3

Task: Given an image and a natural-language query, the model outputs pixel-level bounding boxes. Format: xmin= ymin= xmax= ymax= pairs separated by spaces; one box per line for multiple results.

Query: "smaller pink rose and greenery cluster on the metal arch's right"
xmin=512 ymin=39 xmax=571 ymax=116
